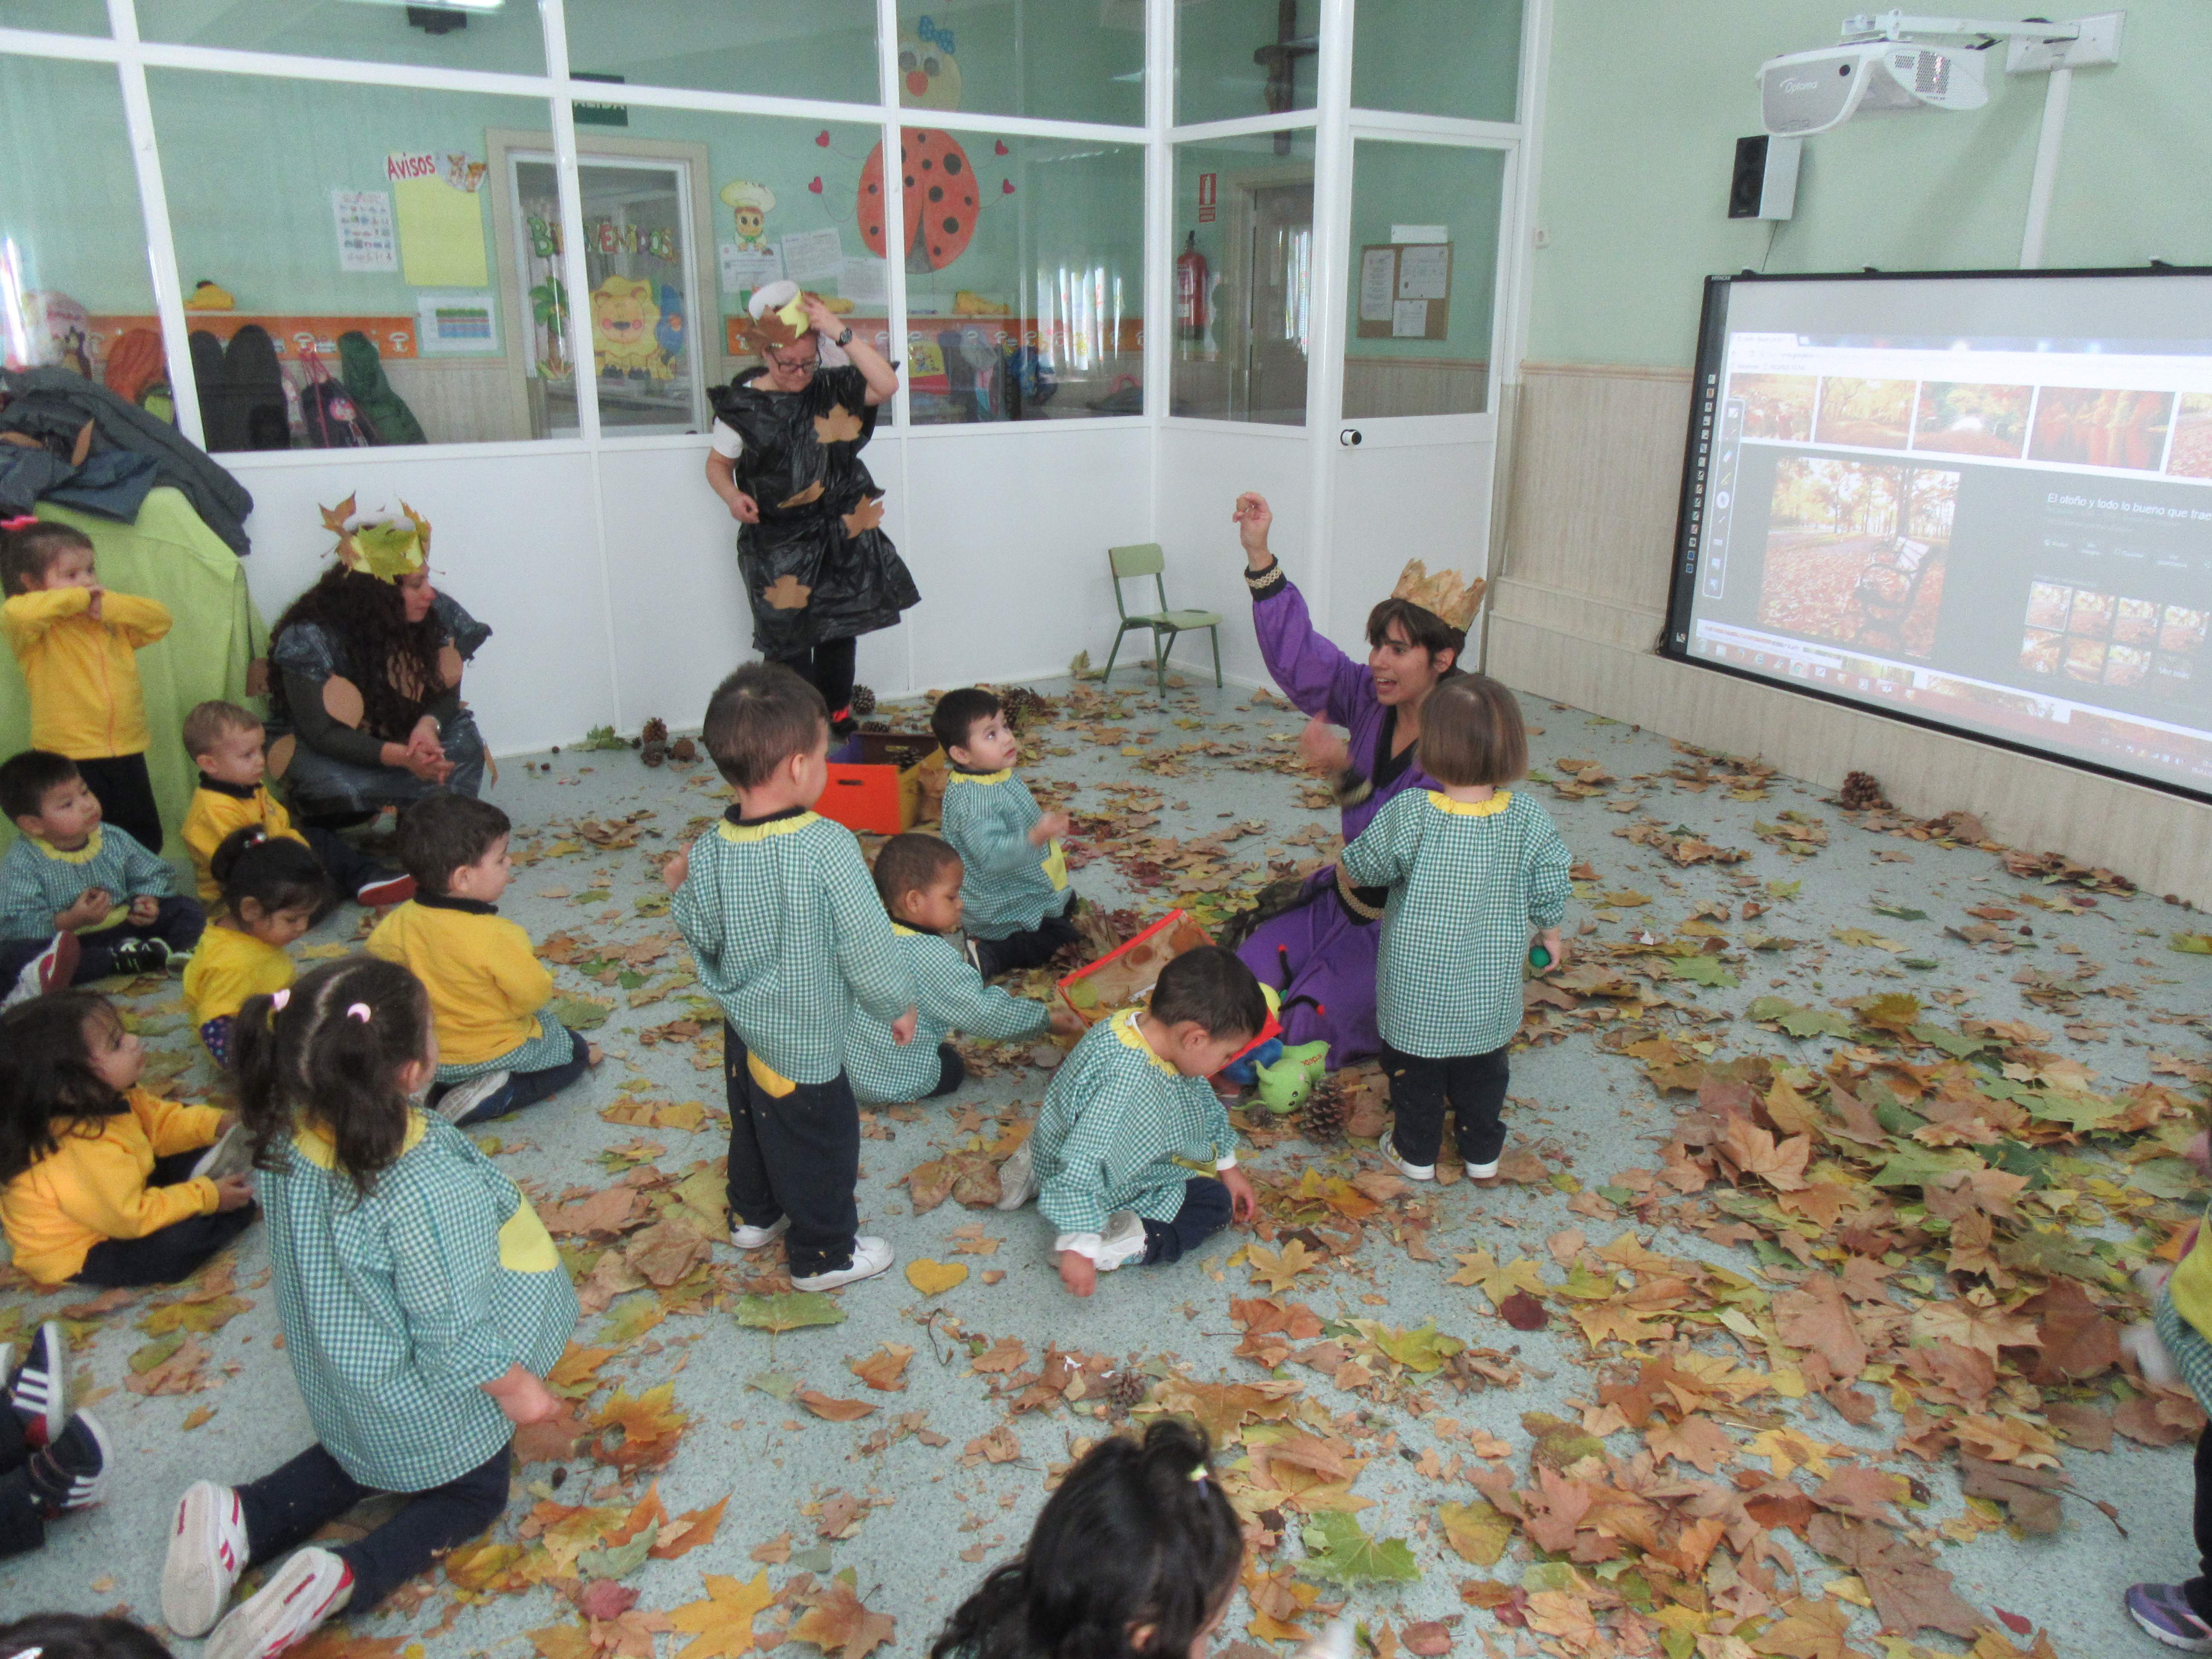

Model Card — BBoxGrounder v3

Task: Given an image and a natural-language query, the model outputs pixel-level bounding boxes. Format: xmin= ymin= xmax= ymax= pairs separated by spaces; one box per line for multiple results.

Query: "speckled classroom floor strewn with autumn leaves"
xmin=0 ymin=670 xmax=2212 ymax=1659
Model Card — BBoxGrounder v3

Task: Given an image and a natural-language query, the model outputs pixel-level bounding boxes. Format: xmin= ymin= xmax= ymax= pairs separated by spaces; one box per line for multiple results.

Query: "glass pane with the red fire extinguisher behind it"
xmin=1168 ymin=133 xmax=1314 ymax=427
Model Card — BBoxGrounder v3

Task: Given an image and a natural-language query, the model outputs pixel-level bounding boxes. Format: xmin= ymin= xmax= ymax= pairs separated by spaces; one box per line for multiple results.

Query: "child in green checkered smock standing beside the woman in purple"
xmin=1341 ymin=675 xmax=1573 ymax=1181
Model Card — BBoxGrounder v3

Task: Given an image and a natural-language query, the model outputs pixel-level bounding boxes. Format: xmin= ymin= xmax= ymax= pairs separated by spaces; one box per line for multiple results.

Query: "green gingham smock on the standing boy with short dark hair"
xmin=675 ymin=807 xmax=916 ymax=1084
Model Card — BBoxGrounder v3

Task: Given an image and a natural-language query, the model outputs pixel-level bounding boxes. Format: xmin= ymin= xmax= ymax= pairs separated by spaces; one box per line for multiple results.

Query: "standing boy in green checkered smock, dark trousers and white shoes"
xmin=661 ymin=661 xmax=916 ymax=1289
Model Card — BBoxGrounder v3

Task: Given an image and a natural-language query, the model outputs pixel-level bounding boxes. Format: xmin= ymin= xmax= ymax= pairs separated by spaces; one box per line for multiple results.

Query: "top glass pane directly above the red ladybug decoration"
xmin=898 ymin=0 xmax=1144 ymax=126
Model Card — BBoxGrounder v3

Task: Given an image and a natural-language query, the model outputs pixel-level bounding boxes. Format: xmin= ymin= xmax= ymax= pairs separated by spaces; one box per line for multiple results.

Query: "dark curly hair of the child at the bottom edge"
xmin=929 ymin=1418 xmax=1243 ymax=1659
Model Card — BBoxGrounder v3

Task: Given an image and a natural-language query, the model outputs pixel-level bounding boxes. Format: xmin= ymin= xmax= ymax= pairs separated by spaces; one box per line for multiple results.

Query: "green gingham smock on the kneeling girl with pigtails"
xmin=259 ymin=1110 xmax=577 ymax=1491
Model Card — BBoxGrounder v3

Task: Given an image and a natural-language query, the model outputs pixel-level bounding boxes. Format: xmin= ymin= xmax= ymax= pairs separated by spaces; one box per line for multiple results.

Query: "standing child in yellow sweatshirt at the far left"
xmin=0 ymin=518 xmax=170 ymax=852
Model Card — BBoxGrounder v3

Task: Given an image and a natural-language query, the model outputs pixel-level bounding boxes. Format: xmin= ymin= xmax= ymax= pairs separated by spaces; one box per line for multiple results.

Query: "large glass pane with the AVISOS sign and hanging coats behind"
xmin=146 ymin=69 xmax=551 ymax=451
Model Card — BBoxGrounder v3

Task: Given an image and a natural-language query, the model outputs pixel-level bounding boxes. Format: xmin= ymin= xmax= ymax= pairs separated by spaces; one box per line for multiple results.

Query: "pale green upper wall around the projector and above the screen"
xmin=1526 ymin=0 xmax=2212 ymax=367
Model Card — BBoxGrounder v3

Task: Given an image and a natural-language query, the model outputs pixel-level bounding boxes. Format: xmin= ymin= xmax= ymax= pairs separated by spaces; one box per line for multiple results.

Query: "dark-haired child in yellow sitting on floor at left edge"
xmin=0 ymin=991 xmax=254 ymax=1285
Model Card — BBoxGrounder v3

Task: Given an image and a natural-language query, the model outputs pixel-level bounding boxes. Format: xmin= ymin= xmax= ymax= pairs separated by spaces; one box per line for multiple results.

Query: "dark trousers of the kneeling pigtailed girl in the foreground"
xmin=237 ymin=1447 xmax=511 ymax=1617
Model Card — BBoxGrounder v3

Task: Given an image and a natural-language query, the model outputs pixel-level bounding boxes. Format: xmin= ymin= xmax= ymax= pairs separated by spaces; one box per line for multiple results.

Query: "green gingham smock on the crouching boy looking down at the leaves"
xmin=1031 ymin=1009 xmax=1237 ymax=1254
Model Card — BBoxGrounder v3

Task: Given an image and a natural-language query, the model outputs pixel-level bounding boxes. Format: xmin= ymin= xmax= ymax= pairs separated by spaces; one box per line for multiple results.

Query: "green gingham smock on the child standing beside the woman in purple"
xmin=1341 ymin=790 xmax=1573 ymax=1059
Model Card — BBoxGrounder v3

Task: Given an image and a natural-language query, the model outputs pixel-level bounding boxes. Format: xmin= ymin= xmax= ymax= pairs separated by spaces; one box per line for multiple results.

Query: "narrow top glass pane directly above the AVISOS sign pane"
xmin=137 ymin=0 xmax=546 ymax=75
